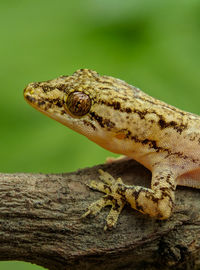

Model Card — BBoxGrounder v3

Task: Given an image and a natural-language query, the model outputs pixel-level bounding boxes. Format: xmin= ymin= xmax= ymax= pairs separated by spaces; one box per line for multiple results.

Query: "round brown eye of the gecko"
xmin=65 ymin=92 xmax=91 ymax=116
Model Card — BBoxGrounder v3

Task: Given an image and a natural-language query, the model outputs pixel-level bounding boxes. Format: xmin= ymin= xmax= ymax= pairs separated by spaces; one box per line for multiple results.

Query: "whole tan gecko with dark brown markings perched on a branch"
xmin=24 ymin=69 xmax=200 ymax=230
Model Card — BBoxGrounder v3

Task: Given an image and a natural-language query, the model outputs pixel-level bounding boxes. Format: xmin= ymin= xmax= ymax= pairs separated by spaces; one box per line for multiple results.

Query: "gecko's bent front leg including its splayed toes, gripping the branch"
xmin=83 ymin=169 xmax=176 ymax=229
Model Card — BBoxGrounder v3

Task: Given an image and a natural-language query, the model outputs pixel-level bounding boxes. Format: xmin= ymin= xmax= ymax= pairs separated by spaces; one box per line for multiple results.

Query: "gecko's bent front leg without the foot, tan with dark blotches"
xmin=125 ymin=169 xmax=176 ymax=219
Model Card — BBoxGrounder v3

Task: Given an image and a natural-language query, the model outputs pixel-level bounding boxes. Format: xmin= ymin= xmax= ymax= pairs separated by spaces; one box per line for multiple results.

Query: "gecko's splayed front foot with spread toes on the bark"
xmin=82 ymin=170 xmax=125 ymax=230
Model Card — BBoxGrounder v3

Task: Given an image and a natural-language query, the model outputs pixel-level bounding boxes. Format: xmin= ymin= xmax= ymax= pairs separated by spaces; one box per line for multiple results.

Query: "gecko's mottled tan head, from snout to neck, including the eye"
xmin=24 ymin=69 xmax=139 ymax=153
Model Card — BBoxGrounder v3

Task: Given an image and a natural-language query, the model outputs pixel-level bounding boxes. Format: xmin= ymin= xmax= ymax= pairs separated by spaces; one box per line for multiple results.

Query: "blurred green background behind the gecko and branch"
xmin=0 ymin=0 xmax=200 ymax=270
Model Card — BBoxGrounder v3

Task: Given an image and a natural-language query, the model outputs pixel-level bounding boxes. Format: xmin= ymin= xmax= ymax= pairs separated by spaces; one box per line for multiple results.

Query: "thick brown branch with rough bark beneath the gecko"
xmin=0 ymin=161 xmax=200 ymax=270
